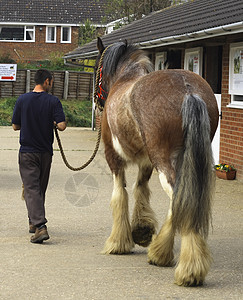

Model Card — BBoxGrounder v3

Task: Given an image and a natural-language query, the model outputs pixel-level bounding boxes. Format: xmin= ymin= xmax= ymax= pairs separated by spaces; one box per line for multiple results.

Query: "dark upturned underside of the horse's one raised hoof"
xmin=132 ymin=226 xmax=155 ymax=247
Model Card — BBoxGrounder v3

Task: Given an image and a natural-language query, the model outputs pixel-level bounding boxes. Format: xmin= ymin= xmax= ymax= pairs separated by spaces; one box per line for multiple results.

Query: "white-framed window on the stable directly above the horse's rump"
xmin=184 ymin=47 xmax=203 ymax=76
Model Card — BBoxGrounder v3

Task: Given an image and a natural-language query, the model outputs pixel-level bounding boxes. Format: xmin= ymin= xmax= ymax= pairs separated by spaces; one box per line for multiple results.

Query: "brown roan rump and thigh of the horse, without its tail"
xmin=130 ymin=70 xmax=218 ymax=177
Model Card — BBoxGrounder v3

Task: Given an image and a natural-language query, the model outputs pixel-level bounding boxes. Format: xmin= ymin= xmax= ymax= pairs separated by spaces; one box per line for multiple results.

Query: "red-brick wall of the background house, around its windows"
xmin=0 ymin=26 xmax=79 ymax=61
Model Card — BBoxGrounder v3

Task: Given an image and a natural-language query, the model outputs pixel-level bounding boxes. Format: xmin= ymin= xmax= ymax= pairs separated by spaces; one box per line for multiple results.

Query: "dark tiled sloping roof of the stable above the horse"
xmin=64 ymin=0 xmax=243 ymax=57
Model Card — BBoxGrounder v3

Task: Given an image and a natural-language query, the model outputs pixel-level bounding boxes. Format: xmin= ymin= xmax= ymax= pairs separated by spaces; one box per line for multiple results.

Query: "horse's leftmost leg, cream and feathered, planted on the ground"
xmin=103 ymin=168 xmax=134 ymax=254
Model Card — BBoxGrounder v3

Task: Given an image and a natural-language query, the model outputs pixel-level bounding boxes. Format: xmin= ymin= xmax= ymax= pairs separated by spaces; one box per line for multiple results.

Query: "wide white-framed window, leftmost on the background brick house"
xmin=0 ymin=25 xmax=35 ymax=42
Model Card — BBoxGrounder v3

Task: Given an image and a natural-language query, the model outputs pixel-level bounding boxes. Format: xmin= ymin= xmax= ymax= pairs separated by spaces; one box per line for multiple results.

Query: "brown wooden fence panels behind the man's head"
xmin=0 ymin=70 xmax=93 ymax=101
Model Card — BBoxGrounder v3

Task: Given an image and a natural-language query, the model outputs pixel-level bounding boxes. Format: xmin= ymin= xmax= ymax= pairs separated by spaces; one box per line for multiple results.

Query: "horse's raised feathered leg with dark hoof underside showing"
xmin=132 ymin=162 xmax=157 ymax=247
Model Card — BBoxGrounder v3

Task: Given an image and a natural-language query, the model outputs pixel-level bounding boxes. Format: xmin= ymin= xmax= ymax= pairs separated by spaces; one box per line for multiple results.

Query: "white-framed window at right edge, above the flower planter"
xmin=228 ymin=42 xmax=243 ymax=109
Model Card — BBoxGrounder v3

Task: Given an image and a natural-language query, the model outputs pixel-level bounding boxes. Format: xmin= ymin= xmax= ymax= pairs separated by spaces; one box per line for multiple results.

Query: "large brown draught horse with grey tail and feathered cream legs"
xmin=97 ymin=38 xmax=219 ymax=286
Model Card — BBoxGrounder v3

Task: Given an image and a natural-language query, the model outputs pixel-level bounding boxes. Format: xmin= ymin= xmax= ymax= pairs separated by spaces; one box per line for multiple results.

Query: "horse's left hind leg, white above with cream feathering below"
xmin=148 ymin=172 xmax=175 ymax=267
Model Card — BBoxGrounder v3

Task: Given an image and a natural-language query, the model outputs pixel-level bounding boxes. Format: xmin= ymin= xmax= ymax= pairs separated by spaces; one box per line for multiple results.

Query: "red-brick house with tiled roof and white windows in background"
xmin=0 ymin=0 xmax=106 ymax=61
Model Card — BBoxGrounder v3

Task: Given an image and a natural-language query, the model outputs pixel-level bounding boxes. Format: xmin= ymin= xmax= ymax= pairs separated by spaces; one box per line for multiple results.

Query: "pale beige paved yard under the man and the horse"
xmin=0 ymin=127 xmax=243 ymax=300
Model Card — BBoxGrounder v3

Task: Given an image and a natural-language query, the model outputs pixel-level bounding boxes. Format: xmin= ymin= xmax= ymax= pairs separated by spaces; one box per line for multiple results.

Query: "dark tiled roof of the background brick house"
xmin=0 ymin=0 xmax=106 ymax=24
